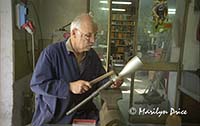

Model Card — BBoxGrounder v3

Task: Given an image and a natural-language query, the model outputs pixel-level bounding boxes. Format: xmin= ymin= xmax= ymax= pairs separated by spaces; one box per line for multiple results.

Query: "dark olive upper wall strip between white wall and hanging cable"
xmin=12 ymin=0 xmax=32 ymax=80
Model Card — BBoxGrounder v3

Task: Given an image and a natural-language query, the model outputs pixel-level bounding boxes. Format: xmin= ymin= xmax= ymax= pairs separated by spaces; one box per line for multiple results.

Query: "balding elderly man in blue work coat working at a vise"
xmin=30 ymin=14 xmax=121 ymax=126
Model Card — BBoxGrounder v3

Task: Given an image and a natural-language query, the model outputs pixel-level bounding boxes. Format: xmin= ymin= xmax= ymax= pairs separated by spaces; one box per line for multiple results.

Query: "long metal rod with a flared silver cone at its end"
xmin=66 ymin=56 xmax=143 ymax=115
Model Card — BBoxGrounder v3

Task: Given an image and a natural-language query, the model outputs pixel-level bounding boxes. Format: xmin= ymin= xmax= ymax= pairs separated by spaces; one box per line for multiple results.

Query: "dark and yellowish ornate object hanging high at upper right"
xmin=152 ymin=0 xmax=168 ymax=29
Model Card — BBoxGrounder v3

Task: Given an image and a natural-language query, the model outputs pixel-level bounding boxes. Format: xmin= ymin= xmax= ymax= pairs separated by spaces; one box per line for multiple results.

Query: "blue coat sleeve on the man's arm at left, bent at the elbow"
xmin=30 ymin=48 xmax=70 ymax=99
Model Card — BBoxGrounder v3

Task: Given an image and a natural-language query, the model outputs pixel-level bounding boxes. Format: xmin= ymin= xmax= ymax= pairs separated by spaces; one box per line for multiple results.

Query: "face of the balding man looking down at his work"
xmin=75 ymin=25 xmax=97 ymax=52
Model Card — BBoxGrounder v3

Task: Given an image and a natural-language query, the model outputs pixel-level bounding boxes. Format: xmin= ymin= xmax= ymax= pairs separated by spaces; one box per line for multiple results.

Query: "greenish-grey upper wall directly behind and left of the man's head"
xmin=38 ymin=0 xmax=87 ymax=39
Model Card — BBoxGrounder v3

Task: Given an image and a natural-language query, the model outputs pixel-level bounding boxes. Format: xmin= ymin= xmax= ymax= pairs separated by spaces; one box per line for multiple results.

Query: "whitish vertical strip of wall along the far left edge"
xmin=0 ymin=0 xmax=14 ymax=126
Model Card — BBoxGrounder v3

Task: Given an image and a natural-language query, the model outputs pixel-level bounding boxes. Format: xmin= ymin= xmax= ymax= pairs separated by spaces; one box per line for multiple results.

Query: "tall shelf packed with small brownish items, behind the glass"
xmin=110 ymin=0 xmax=137 ymax=63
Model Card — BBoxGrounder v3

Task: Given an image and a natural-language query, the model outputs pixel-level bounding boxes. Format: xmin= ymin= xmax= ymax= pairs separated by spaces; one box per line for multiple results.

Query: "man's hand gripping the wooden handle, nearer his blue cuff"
xmin=69 ymin=80 xmax=91 ymax=94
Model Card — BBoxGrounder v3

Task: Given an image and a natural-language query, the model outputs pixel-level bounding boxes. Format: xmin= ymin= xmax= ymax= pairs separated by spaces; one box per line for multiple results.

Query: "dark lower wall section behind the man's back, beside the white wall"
xmin=12 ymin=74 xmax=34 ymax=126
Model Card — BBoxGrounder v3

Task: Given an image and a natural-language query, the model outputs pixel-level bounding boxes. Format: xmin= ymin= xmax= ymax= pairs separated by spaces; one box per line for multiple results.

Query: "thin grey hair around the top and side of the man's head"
xmin=70 ymin=13 xmax=96 ymax=32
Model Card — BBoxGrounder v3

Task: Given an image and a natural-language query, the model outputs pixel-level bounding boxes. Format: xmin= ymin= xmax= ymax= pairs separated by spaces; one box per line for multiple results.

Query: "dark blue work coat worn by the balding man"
xmin=30 ymin=41 xmax=108 ymax=126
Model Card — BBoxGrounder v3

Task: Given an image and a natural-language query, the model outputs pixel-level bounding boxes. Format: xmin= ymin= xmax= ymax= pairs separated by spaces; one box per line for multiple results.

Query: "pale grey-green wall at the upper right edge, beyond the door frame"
xmin=183 ymin=0 xmax=200 ymax=71
